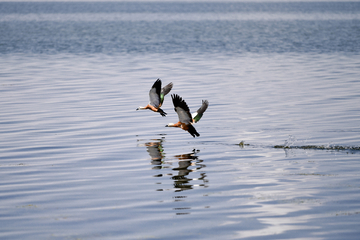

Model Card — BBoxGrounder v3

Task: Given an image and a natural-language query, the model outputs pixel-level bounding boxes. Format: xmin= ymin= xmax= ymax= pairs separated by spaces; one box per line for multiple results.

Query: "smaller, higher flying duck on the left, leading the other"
xmin=136 ymin=79 xmax=173 ymax=117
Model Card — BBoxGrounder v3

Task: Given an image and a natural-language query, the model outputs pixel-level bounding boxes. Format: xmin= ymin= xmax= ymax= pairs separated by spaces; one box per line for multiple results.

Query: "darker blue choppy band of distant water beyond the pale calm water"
xmin=0 ymin=2 xmax=360 ymax=54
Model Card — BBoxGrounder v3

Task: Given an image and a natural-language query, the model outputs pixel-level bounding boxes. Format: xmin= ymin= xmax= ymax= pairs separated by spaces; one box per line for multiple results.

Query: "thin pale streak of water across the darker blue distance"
xmin=0 ymin=12 xmax=360 ymax=22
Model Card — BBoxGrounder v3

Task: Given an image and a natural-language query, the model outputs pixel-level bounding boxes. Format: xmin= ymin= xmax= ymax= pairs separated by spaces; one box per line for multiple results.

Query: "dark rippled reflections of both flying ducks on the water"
xmin=138 ymin=137 xmax=208 ymax=215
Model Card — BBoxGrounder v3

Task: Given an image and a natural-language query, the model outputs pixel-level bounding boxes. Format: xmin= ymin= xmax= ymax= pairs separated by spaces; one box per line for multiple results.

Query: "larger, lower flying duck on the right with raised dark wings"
xmin=165 ymin=94 xmax=209 ymax=137
